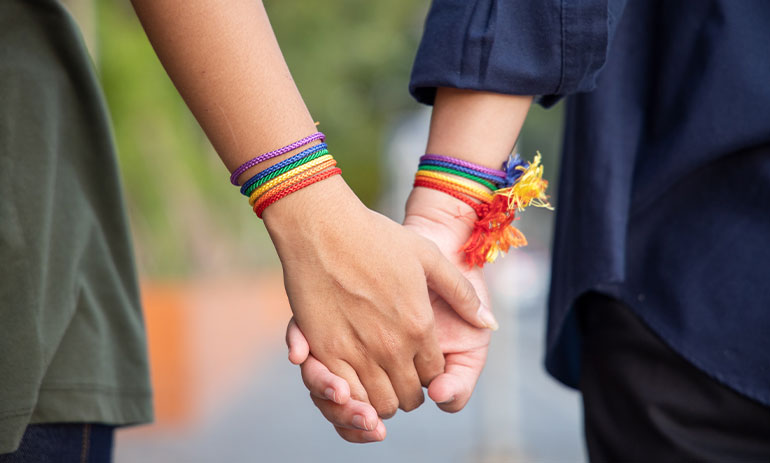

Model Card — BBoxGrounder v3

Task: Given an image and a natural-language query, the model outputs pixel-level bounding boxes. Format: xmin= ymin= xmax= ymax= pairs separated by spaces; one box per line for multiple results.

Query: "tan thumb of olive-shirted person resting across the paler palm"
xmin=423 ymin=242 xmax=499 ymax=331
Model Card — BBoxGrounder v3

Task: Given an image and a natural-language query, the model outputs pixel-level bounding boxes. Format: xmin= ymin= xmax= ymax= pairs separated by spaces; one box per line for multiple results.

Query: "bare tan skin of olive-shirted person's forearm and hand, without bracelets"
xmin=127 ymin=0 xmax=493 ymax=417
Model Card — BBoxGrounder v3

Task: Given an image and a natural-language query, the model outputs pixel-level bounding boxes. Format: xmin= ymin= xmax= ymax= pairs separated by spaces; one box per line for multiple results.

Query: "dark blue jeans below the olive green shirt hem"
xmin=0 ymin=423 xmax=115 ymax=463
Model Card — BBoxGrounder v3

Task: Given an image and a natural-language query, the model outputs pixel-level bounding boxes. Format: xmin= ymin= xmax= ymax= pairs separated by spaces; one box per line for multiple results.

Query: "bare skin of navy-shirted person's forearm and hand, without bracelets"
xmin=286 ymin=88 xmax=532 ymax=443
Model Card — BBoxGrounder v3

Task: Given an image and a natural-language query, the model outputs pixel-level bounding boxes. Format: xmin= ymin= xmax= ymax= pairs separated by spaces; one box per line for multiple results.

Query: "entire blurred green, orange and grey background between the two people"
xmin=65 ymin=0 xmax=585 ymax=463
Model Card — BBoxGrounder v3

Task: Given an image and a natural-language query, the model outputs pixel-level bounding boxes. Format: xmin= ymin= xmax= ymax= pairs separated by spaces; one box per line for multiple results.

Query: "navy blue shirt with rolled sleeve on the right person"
xmin=410 ymin=0 xmax=770 ymax=405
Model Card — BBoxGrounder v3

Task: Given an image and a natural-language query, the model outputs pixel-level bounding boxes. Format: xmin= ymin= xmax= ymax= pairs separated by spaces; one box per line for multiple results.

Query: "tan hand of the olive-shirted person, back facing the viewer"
xmin=264 ymin=177 xmax=483 ymax=422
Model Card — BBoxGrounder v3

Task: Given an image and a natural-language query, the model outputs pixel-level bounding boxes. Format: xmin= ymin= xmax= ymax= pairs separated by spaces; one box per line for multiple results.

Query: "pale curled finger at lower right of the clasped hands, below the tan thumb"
xmin=428 ymin=350 xmax=486 ymax=413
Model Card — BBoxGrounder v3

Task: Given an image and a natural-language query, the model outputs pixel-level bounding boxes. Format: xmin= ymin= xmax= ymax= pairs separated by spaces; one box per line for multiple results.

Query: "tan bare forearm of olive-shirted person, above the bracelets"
xmin=132 ymin=0 xmax=315 ymax=182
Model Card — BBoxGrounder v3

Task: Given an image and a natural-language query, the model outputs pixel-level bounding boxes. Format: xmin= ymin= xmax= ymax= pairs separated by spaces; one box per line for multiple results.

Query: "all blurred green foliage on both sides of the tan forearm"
xmin=95 ymin=0 xmax=427 ymax=276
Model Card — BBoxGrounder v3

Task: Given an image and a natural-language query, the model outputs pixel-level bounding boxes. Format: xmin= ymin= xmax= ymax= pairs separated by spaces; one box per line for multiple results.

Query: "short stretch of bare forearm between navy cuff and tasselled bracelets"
xmin=426 ymin=88 xmax=532 ymax=169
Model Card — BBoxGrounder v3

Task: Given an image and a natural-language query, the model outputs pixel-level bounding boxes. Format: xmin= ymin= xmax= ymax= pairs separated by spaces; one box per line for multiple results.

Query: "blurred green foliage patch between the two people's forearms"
xmin=265 ymin=0 xmax=427 ymax=205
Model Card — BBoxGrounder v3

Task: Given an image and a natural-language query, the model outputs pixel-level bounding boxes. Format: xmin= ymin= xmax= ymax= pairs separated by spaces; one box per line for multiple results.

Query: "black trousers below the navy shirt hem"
xmin=577 ymin=293 xmax=770 ymax=463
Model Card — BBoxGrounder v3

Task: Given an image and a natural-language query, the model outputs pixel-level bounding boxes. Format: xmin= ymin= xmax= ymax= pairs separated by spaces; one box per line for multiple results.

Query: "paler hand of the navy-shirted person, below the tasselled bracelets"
xmin=286 ymin=188 xmax=496 ymax=442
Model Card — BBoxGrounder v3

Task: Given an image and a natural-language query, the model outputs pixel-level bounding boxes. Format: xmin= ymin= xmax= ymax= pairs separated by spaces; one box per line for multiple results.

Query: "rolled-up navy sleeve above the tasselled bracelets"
xmin=409 ymin=0 xmax=626 ymax=106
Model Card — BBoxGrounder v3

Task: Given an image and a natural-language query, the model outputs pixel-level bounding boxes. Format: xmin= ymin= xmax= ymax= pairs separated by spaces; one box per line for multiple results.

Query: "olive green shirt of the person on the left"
xmin=0 ymin=0 xmax=152 ymax=454
